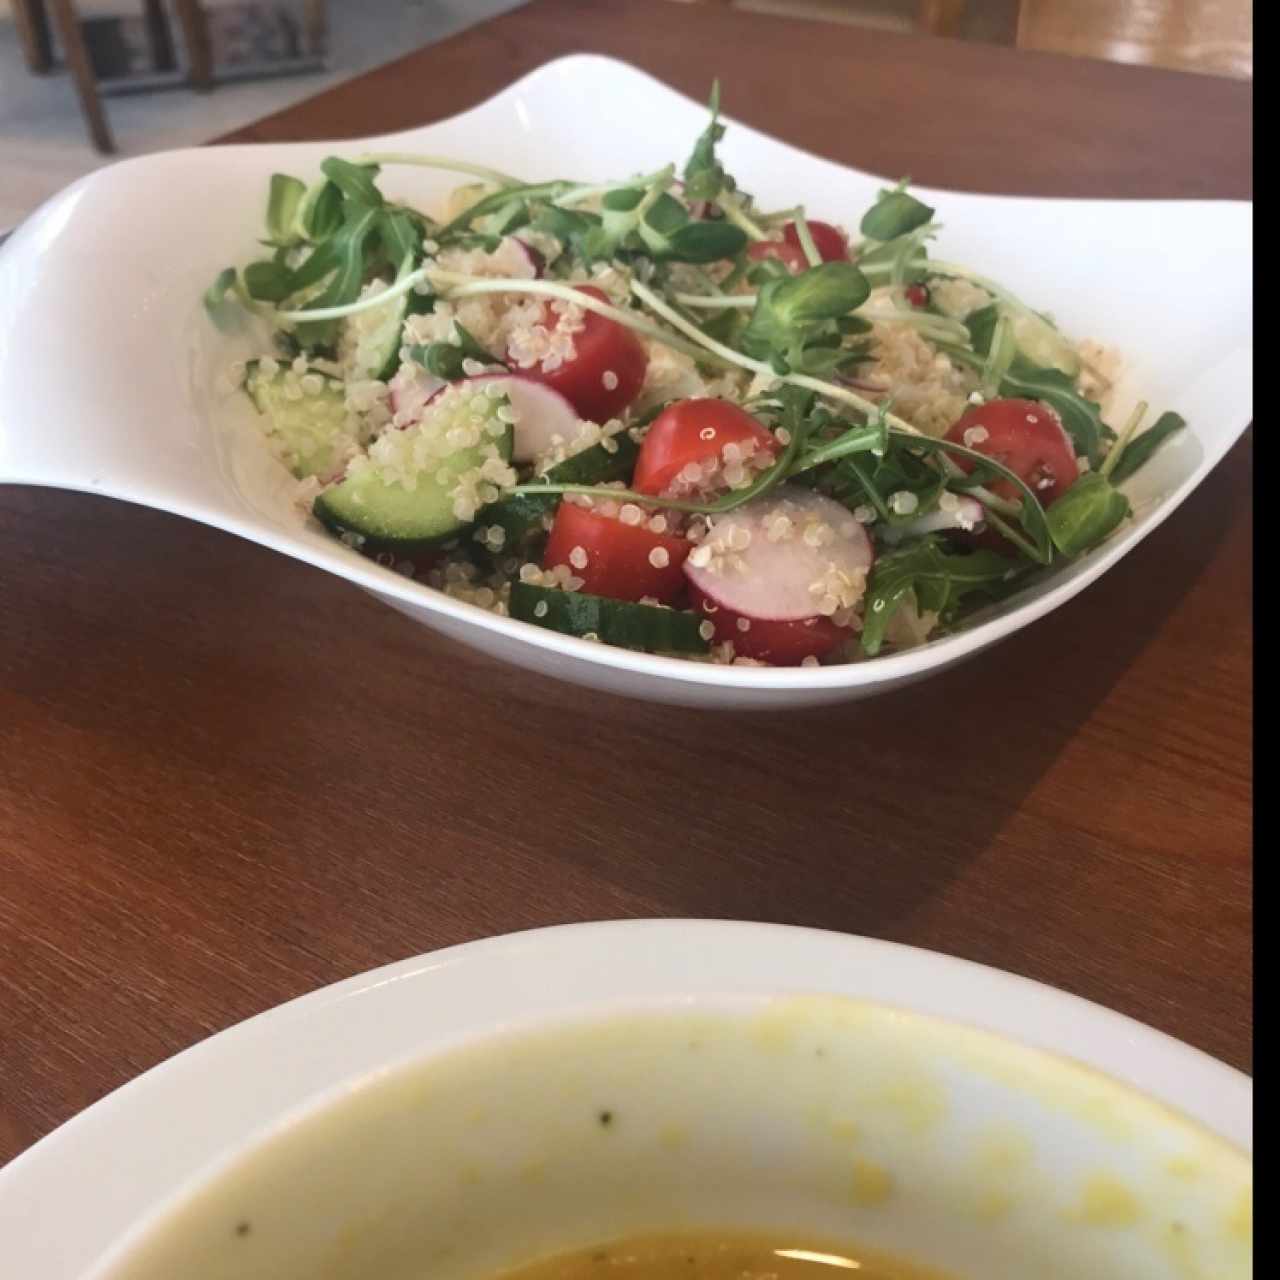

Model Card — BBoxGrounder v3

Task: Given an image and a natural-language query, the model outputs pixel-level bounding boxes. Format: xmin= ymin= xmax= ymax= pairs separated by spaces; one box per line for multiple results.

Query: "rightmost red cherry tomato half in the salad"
xmin=947 ymin=399 xmax=1080 ymax=507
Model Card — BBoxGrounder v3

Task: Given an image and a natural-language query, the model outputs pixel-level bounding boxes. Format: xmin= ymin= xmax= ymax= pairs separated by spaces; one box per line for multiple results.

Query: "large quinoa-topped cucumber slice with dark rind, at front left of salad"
xmin=312 ymin=385 xmax=515 ymax=554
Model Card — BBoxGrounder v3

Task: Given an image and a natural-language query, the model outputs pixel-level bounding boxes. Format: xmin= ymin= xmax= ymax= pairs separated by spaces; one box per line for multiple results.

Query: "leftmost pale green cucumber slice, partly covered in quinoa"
xmin=244 ymin=360 xmax=360 ymax=480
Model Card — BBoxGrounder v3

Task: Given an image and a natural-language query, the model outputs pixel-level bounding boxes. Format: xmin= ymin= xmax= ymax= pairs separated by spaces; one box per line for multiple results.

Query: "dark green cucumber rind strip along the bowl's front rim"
xmin=509 ymin=582 xmax=710 ymax=653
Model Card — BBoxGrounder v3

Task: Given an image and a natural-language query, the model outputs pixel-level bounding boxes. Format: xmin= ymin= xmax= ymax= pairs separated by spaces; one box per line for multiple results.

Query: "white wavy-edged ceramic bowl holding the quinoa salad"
xmin=0 ymin=55 xmax=1253 ymax=707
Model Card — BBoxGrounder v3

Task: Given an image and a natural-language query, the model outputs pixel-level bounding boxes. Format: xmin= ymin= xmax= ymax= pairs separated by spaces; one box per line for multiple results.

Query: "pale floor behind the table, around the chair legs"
xmin=0 ymin=0 xmax=520 ymax=230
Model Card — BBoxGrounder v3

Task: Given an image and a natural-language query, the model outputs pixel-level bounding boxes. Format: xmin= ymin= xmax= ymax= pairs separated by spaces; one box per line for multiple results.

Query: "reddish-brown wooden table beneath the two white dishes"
xmin=0 ymin=0 xmax=1252 ymax=1160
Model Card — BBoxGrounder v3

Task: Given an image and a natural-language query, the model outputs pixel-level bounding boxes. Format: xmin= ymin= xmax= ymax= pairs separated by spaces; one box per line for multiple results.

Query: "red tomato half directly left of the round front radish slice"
xmin=543 ymin=502 xmax=692 ymax=604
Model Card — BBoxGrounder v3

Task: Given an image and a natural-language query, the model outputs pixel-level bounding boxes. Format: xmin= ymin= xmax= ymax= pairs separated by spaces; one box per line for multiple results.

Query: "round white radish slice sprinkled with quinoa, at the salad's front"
xmin=685 ymin=486 xmax=876 ymax=622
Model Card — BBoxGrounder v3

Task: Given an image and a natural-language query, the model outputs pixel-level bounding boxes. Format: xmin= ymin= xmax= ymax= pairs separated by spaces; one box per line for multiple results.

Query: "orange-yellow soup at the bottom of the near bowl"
xmin=497 ymin=1231 xmax=951 ymax=1280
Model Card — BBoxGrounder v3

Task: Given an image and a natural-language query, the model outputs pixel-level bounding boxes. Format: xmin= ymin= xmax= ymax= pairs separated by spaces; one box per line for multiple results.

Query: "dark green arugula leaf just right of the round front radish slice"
xmin=861 ymin=536 xmax=1021 ymax=658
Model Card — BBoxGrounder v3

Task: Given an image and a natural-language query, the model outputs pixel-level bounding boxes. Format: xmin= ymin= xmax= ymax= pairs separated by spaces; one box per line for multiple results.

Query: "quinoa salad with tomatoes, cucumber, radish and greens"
xmin=205 ymin=90 xmax=1185 ymax=666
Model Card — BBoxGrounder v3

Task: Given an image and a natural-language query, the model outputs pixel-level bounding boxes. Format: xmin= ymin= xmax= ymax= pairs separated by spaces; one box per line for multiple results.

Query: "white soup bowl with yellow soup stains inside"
xmin=67 ymin=922 xmax=1252 ymax=1280
